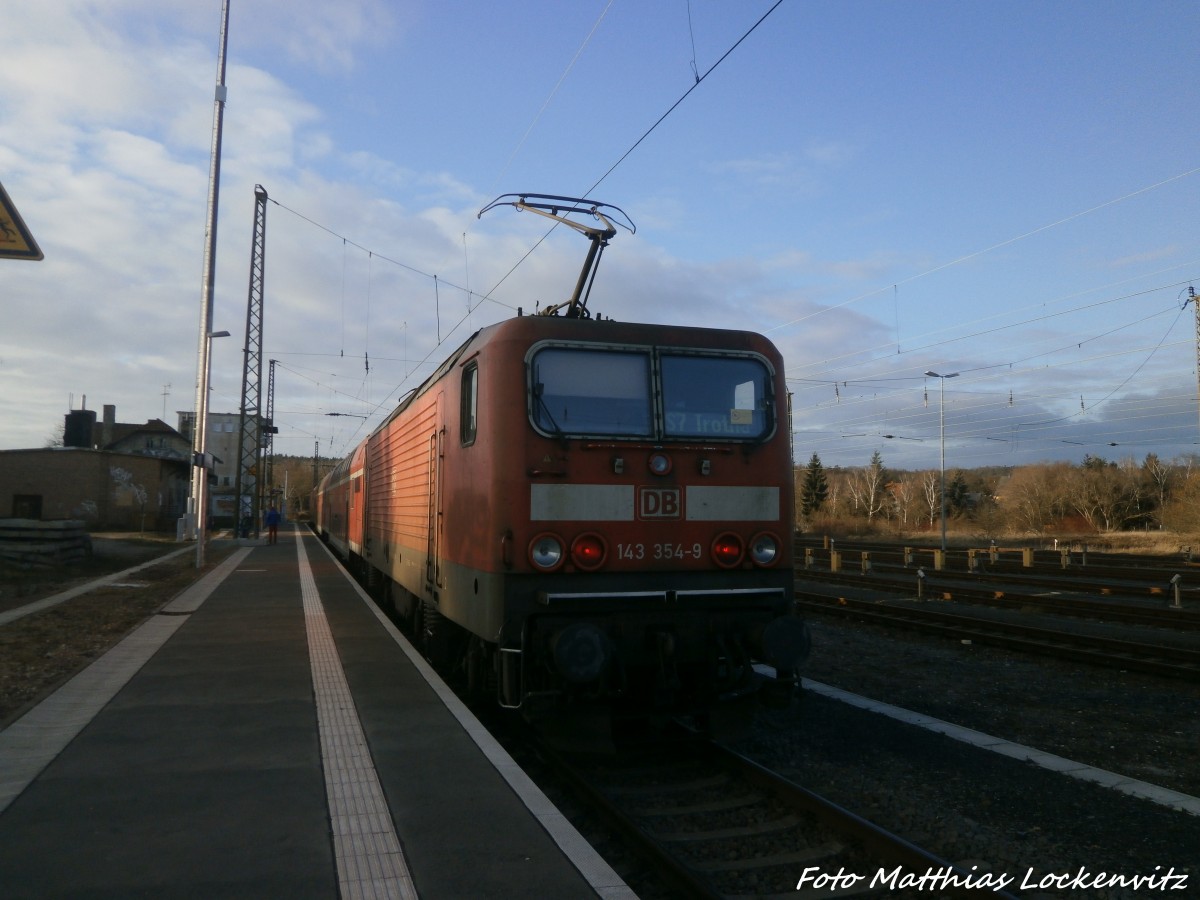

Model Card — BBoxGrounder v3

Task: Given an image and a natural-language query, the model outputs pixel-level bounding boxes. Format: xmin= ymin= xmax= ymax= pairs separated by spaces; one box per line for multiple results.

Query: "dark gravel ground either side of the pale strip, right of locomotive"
xmin=737 ymin=619 xmax=1200 ymax=900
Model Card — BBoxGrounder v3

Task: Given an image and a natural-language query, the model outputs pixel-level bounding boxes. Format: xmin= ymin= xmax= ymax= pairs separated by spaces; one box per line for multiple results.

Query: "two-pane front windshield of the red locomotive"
xmin=529 ymin=346 xmax=774 ymax=440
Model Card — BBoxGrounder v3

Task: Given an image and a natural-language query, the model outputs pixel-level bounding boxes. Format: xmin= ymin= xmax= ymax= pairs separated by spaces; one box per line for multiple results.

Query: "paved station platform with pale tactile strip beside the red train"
xmin=0 ymin=527 xmax=634 ymax=900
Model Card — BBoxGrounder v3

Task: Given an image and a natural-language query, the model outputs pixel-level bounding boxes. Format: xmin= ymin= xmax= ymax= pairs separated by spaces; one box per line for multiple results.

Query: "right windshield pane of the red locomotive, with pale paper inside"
xmin=660 ymin=353 xmax=774 ymax=440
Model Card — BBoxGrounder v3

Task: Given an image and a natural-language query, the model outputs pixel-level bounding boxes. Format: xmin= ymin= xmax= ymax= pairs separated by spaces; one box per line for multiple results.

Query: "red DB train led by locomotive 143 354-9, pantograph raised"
xmin=313 ymin=194 xmax=809 ymax=727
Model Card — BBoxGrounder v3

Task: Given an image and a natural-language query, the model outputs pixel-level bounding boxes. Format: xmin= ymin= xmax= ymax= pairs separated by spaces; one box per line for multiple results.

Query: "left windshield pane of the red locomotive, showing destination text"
xmin=529 ymin=347 xmax=653 ymax=437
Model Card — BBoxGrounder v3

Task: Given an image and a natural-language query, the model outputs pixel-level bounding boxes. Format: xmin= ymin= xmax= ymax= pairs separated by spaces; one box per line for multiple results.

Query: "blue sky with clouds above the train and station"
xmin=0 ymin=0 xmax=1200 ymax=468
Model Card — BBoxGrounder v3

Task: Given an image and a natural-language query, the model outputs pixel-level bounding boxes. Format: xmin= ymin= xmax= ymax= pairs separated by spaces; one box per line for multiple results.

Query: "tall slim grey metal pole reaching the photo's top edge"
xmin=190 ymin=0 xmax=229 ymax=569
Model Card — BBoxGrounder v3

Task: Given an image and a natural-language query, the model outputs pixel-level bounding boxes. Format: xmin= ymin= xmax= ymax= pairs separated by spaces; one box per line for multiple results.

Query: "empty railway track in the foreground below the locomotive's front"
xmin=540 ymin=738 xmax=1012 ymax=900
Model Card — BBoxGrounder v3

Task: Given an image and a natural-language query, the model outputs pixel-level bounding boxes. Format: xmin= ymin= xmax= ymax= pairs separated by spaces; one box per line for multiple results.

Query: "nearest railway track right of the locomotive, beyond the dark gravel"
xmin=796 ymin=589 xmax=1200 ymax=680
